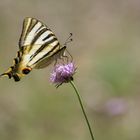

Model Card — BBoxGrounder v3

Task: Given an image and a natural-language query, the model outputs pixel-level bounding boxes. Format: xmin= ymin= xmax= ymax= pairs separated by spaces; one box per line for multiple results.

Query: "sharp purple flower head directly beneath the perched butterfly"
xmin=50 ymin=62 xmax=76 ymax=86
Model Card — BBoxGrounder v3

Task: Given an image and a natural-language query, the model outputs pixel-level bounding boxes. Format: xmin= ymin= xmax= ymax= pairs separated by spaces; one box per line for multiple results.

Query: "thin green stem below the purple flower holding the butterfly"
xmin=70 ymin=81 xmax=94 ymax=140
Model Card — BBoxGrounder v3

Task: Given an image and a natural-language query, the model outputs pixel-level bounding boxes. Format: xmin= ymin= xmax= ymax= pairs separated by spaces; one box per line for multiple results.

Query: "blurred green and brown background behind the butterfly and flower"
xmin=0 ymin=0 xmax=140 ymax=140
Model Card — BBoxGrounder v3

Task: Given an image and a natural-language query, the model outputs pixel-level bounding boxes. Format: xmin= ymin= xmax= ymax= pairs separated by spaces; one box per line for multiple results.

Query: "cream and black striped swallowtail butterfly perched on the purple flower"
xmin=0 ymin=17 xmax=72 ymax=81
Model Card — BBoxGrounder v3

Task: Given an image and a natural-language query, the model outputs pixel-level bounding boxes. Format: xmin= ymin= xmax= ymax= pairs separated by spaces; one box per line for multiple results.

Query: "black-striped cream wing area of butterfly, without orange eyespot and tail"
xmin=19 ymin=18 xmax=63 ymax=68
